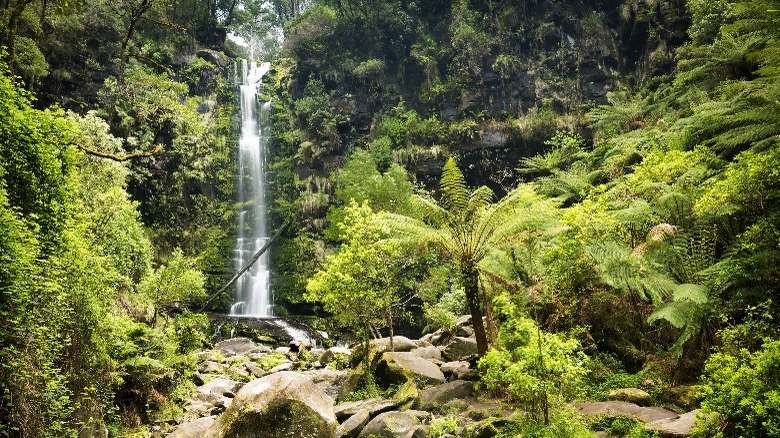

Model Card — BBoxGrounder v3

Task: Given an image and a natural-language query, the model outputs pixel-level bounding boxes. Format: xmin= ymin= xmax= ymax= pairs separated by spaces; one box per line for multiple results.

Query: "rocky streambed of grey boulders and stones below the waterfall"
xmin=152 ymin=318 xmax=695 ymax=438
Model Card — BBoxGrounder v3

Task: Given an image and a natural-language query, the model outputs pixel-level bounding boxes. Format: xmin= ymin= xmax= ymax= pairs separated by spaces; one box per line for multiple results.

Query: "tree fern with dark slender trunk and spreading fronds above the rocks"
xmin=380 ymin=158 xmax=554 ymax=357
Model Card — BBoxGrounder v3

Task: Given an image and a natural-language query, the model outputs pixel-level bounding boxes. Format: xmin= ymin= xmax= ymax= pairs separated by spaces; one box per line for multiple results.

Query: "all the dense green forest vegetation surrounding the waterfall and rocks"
xmin=0 ymin=0 xmax=780 ymax=437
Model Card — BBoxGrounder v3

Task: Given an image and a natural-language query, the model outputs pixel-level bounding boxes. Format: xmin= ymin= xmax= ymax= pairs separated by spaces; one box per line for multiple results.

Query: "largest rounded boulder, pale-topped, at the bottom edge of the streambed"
xmin=205 ymin=371 xmax=337 ymax=438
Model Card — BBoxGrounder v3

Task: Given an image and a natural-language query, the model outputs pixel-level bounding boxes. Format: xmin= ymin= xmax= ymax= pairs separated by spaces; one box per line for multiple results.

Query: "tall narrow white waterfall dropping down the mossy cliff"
xmin=230 ymin=60 xmax=273 ymax=317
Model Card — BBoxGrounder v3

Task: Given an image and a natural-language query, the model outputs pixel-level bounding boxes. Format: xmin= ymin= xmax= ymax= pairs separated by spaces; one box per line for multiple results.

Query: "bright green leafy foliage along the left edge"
xmin=0 ymin=63 xmax=213 ymax=437
